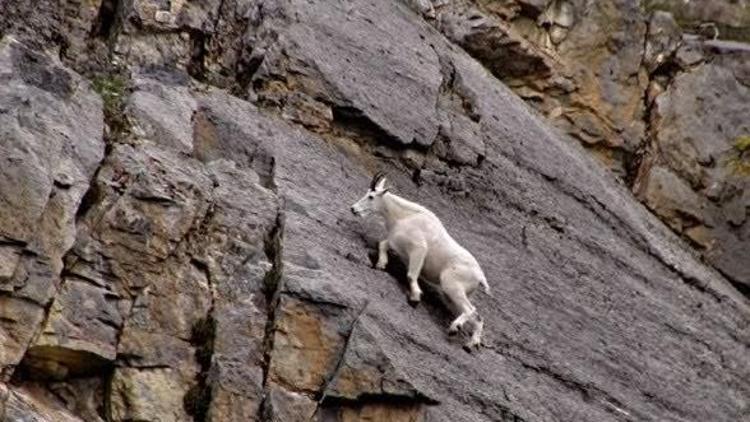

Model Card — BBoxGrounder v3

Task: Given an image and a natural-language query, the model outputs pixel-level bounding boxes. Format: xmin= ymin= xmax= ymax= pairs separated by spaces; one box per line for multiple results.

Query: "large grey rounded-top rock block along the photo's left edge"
xmin=0 ymin=37 xmax=104 ymax=378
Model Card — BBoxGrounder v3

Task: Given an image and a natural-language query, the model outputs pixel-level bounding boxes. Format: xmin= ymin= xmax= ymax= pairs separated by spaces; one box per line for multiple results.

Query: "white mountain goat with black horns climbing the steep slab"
xmin=352 ymin=173 xmax=490 ymax=350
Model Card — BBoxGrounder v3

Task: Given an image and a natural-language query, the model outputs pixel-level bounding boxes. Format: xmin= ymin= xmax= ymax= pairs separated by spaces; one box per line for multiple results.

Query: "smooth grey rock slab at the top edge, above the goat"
xmin=254 ymin=0 xmax=441 ymax=146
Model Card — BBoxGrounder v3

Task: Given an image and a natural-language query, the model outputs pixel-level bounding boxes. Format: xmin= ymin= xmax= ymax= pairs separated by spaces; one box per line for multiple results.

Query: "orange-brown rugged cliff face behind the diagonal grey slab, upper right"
xmin=402 ymin=0 xmax=750 ymax=289
